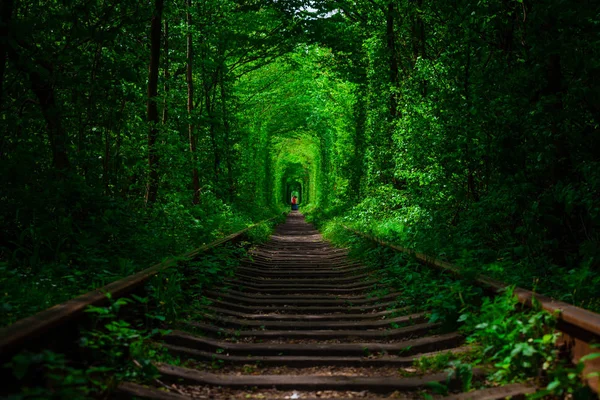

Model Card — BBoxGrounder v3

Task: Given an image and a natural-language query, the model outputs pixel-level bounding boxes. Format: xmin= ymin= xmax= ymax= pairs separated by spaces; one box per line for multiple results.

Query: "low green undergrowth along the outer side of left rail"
xmin=0 ymin=212 xmax=280 ymax=326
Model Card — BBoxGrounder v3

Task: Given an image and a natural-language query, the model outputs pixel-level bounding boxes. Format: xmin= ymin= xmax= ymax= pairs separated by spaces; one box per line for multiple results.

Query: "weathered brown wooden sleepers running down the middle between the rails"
xmin=2 ymin=212 xmax=600 ymax=400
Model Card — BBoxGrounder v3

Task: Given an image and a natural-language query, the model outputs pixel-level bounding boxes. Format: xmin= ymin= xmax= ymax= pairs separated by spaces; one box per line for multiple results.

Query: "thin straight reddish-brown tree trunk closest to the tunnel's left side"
xmin=186 ymin=0 xmax=200 ymax=204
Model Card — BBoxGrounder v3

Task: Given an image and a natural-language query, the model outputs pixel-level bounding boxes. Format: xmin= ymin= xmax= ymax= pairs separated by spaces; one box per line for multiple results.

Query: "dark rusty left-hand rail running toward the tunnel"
xmin=0 ymin=217 xmax=277 ymax=360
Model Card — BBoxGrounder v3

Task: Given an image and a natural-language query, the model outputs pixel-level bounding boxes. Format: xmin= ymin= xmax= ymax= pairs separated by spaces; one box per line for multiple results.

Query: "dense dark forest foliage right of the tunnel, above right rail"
xmin=302 ymin=0 xmax=600 ymax=309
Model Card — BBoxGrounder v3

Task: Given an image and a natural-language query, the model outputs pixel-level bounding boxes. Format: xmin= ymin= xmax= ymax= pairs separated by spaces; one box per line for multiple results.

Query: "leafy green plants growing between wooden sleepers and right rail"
xmin=326 ymin=224 xmax=600 ymax=399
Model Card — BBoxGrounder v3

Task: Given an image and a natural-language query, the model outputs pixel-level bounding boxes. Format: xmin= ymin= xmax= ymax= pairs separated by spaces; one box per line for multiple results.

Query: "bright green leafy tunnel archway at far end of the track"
xmin=238 ymin=47 xmax=355 ymax=212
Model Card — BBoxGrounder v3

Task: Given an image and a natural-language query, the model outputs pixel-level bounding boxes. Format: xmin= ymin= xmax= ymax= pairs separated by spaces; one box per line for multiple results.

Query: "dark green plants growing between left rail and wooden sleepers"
xmin=3 ymin=236 xmax=271 ymax=400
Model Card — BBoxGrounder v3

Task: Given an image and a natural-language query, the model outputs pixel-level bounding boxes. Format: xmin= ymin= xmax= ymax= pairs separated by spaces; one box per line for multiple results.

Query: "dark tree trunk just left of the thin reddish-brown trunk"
xmin=146 ymin=0 xmax=164 ymax=206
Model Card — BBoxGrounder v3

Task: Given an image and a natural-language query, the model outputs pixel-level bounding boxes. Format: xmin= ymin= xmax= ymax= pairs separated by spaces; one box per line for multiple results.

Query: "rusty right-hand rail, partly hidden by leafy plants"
xmin=342 ymin=225 xmax=600 ymax=392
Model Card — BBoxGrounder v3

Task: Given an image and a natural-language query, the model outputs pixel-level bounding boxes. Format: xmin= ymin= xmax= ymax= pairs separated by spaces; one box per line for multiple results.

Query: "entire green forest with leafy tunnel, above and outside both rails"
xmin=0 ymin=0 xmax=600 ymax=323
